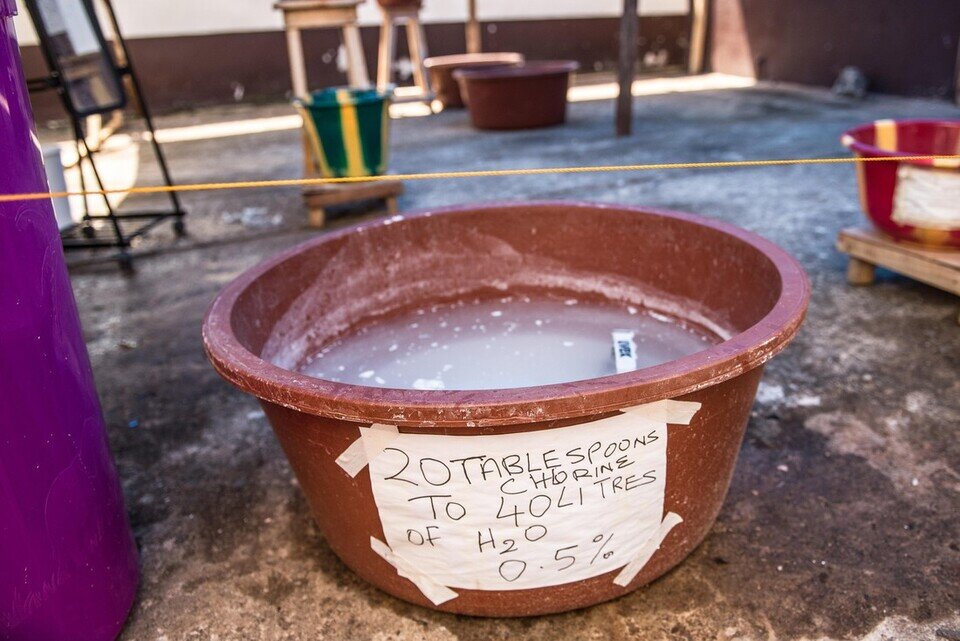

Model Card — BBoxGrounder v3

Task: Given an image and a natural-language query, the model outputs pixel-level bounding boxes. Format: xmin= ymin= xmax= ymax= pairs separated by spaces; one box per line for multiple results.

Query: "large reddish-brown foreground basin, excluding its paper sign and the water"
xmin=203 ymin=202 xmax=809 ymax=616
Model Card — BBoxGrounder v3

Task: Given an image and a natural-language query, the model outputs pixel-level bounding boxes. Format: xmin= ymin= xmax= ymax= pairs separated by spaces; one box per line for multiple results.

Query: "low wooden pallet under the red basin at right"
xmin=837 ymin=227 xmax=960 ymax=323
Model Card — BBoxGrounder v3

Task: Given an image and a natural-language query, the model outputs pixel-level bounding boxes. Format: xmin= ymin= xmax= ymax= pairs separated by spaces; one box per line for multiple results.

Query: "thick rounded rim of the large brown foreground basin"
xmin=203 ymin=201 xmax=810 ymax=427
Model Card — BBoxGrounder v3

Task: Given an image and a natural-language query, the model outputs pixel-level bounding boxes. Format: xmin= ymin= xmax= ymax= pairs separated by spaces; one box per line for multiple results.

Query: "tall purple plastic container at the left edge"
xmin=0 ymin=0 xmax=138 ymax=641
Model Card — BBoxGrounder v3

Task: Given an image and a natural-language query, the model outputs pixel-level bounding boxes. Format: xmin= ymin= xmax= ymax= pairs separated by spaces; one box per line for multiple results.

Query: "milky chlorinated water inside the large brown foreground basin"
xmin=300 ymin=293 xmax=719 ymax=390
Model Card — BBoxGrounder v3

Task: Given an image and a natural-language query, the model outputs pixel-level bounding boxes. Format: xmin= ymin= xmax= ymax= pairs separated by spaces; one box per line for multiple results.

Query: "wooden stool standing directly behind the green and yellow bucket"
xmin=273 ymin=0 xmax=370 ymax=98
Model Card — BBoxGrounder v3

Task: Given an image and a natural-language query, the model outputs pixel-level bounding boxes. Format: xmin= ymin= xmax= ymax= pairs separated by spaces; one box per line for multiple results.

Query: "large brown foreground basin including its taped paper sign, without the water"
xmin=203 ymin=202 xmax=809 ymax=616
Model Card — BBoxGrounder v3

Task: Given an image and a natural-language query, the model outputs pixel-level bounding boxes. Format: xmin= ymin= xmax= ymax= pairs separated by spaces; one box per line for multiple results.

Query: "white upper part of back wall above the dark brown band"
xmin=15 ymin=0 xmax=689 ymax=44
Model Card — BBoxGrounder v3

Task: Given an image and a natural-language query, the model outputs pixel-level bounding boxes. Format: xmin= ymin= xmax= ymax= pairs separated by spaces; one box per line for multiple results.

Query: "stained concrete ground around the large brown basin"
xmin=58 ymin=77 xmax=960 ymax=641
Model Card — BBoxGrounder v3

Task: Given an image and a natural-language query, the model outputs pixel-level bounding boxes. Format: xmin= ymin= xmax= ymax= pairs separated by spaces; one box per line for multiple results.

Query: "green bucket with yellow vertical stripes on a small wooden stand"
xmin=293 ymin=88 xmax=391 ymax=178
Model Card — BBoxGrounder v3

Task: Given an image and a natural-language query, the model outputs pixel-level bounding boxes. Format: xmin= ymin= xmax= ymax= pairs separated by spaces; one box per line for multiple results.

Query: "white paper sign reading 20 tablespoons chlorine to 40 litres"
xmin=338 ymin=401 xmax=700 ymax=603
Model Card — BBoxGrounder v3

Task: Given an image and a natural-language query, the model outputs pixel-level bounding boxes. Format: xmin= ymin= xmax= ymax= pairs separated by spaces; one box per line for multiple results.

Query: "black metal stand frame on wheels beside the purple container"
xmin=28 ymin=0 xmax=187 ymax=271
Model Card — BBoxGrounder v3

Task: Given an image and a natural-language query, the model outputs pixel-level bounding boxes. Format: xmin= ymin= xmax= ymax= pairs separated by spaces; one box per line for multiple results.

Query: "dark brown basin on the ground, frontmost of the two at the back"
xmin=453 ymin=60 xmax=579 ymax=129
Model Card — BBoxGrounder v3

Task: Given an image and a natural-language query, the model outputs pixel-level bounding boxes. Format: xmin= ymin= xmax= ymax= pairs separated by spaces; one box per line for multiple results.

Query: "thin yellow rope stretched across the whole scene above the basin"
xmin=0 ymin=154 xmax=960 ymax=203
